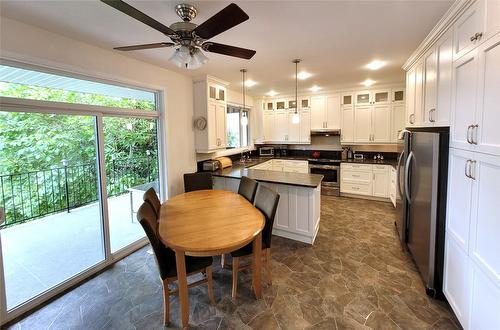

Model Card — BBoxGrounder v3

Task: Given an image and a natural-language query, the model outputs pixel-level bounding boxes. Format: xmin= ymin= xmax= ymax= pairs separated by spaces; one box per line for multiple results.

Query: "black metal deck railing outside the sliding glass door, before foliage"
xmin=0 ymin=155 xmax=158 ymax=229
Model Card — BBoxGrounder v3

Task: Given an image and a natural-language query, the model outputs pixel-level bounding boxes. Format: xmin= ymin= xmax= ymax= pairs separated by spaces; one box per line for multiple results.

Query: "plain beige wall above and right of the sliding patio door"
xmin=0 ymin=17 xmax=196 ymax=196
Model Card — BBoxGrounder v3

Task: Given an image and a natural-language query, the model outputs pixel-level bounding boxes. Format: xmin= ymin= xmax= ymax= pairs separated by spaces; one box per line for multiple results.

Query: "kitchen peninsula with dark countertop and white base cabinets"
xmin=212 ymin=160 xmax=323 ymax=244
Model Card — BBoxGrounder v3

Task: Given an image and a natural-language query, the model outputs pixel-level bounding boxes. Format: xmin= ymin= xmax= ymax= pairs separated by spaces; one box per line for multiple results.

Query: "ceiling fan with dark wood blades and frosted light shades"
xmin=101 ymin=0 xmax=255 ymax=69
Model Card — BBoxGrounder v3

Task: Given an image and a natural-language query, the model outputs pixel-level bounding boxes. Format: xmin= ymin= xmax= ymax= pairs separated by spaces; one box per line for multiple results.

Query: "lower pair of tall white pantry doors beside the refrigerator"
xmin=443 ymin=148 xmax=500 ymax=329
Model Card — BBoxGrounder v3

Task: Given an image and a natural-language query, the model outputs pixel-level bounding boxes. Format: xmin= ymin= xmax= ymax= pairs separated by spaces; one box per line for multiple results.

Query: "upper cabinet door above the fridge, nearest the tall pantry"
xmin=434 ymin=32 xmax=453 ymax=126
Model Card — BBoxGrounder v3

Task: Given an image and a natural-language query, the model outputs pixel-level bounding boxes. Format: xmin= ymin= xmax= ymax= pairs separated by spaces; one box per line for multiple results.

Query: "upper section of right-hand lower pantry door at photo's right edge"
xmin=468 ymin=153 xmax=500 ymax=284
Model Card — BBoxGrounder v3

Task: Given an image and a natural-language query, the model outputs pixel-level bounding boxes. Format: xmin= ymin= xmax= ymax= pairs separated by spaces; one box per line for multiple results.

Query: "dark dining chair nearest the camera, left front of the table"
xmin=137 ymin=203 xmax=215 ymax=325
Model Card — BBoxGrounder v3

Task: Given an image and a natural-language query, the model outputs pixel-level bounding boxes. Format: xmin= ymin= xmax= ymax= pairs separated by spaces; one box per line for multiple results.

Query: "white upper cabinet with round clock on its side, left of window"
xmin=194 ymin=77 xmax=227 ymax=153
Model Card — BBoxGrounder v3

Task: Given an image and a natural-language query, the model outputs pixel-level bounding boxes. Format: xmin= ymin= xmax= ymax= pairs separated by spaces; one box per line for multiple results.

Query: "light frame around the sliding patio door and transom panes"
xmin=0 ymin=58 xmax=168 ymax=326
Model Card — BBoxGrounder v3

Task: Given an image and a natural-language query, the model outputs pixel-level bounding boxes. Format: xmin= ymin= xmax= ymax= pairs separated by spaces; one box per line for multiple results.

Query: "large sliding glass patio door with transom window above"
xmin=0 ymin=64 xmax=165 ymax=326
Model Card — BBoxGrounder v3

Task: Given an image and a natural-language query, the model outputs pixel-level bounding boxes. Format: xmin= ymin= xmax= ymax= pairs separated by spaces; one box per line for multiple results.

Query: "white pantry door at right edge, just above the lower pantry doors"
xmin=474 ymin=34 xmax=500 ymax=156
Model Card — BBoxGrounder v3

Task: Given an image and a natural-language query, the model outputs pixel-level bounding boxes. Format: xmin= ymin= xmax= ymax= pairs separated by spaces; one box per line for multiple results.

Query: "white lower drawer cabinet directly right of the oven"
xmin=340 ymin=163 xmax=392 ymax=198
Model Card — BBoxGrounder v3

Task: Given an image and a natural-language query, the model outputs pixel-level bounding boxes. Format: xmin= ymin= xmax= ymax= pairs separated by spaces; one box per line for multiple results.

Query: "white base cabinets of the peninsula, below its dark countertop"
xmin=214 ymin=176 xmax=321 ymax=244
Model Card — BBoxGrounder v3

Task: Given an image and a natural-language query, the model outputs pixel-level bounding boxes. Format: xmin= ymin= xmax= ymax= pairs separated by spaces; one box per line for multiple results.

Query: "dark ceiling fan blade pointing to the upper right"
xmin=193 ymin=3 xmax=249 ymax=40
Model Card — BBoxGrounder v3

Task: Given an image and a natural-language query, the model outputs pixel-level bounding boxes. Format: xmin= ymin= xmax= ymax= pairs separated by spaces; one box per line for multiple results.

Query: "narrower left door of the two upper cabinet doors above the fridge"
xmin=422 ymin=49 xmax=437 ymax=126
